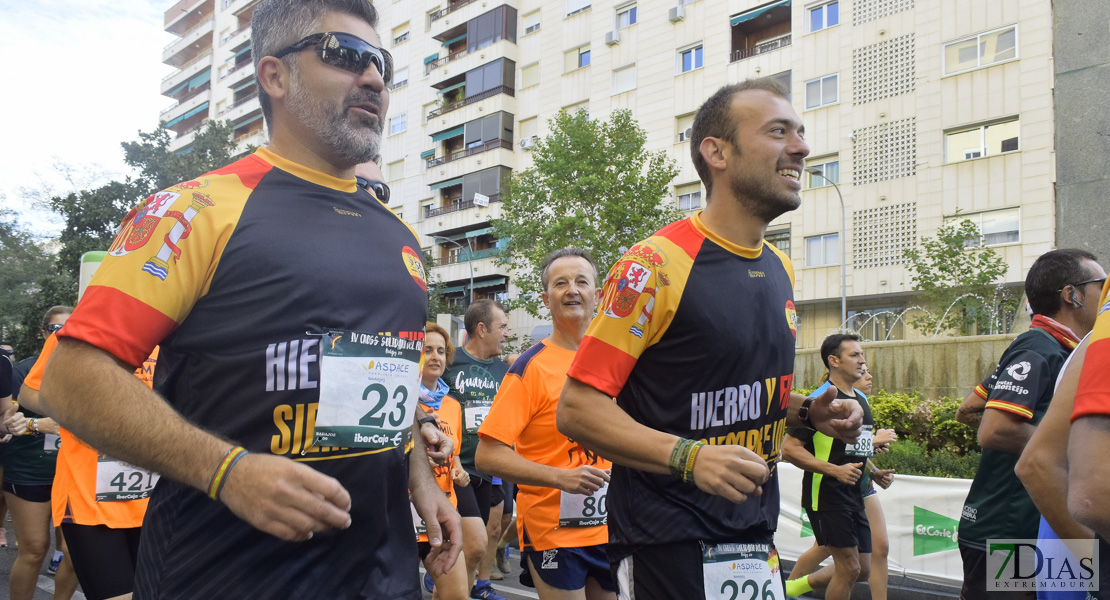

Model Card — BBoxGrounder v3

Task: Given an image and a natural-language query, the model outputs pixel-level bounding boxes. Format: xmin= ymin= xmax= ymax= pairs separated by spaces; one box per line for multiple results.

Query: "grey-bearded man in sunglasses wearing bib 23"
xmin=42 ymin=0 xmax=461 ymax=599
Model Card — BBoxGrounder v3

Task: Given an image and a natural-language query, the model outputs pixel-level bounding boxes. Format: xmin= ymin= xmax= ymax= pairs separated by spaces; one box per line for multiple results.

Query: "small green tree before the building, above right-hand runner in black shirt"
xmin=902 ymin=218 xmax=1020 ymax=335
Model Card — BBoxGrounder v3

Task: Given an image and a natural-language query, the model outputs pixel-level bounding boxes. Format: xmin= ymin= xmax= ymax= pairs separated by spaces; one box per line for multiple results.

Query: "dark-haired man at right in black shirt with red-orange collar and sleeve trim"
xmin=956 ymin=250 xmax=1107 ymax=600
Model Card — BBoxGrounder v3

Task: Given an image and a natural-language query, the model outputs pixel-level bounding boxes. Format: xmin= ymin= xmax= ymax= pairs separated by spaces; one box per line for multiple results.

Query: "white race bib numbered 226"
xmin=702 ymin=543 xmax=786 ymax=600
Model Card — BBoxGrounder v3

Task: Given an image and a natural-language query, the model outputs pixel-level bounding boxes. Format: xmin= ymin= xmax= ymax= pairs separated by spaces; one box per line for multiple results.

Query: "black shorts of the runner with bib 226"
xmin=609 ymin=535 xmax=786 ymax=600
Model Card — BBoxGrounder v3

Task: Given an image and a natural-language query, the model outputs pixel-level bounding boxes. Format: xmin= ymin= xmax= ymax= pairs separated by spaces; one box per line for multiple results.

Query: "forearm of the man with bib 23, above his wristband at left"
xmin=39 ymin=339 xmax=231 ymax=490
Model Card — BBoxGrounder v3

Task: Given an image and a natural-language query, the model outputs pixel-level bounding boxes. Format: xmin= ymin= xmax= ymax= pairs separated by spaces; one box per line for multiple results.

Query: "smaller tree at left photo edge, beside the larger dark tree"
xmin=0 ymin=211 xmax=77 ymax=358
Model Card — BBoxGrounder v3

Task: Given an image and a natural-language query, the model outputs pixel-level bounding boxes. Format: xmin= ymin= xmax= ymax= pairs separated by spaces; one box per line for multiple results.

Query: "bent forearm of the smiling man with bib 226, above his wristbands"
xmin=556 ymin=377 xmax=678 ymax=475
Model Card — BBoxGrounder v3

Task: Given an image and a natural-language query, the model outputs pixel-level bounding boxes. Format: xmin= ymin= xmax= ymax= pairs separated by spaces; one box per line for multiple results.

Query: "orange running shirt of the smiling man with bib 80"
xmin=478 ymin=342 xmax=613 ymax=550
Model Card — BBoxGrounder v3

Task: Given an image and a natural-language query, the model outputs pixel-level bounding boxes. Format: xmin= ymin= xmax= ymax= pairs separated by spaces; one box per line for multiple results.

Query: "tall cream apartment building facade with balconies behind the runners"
xmin=163 ymin=0 xmax=1056 ymax=347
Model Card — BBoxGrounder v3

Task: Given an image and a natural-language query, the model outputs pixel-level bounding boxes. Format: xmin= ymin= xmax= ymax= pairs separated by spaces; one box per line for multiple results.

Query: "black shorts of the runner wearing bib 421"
xmin=62 ymin=523 xmax=142 ymax=600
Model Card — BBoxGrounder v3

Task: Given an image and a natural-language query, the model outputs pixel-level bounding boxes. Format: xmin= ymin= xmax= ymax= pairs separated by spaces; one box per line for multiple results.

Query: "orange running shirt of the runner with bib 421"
xmin=23 ymin=335 xmax=158 ymax=529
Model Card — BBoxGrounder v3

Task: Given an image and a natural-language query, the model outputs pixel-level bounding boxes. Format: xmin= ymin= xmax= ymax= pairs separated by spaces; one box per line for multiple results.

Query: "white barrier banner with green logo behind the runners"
xmin=775 ymin=462 xmax=971 ymax=587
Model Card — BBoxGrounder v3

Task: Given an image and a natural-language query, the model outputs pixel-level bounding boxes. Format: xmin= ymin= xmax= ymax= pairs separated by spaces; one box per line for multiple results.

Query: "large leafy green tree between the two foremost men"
xmin=493 ymin=110 xmax=683 ymax=316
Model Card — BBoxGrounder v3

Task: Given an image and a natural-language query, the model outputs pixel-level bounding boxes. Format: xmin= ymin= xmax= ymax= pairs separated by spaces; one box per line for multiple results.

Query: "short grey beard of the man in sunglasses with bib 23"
xmin=285 ymin=61 xmax=384 ymax=167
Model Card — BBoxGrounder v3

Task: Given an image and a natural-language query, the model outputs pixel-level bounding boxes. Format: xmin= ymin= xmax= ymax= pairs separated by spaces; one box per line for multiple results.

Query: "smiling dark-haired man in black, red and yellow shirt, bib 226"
xmin=558 ymin=79 xmax=862 ymax=600
